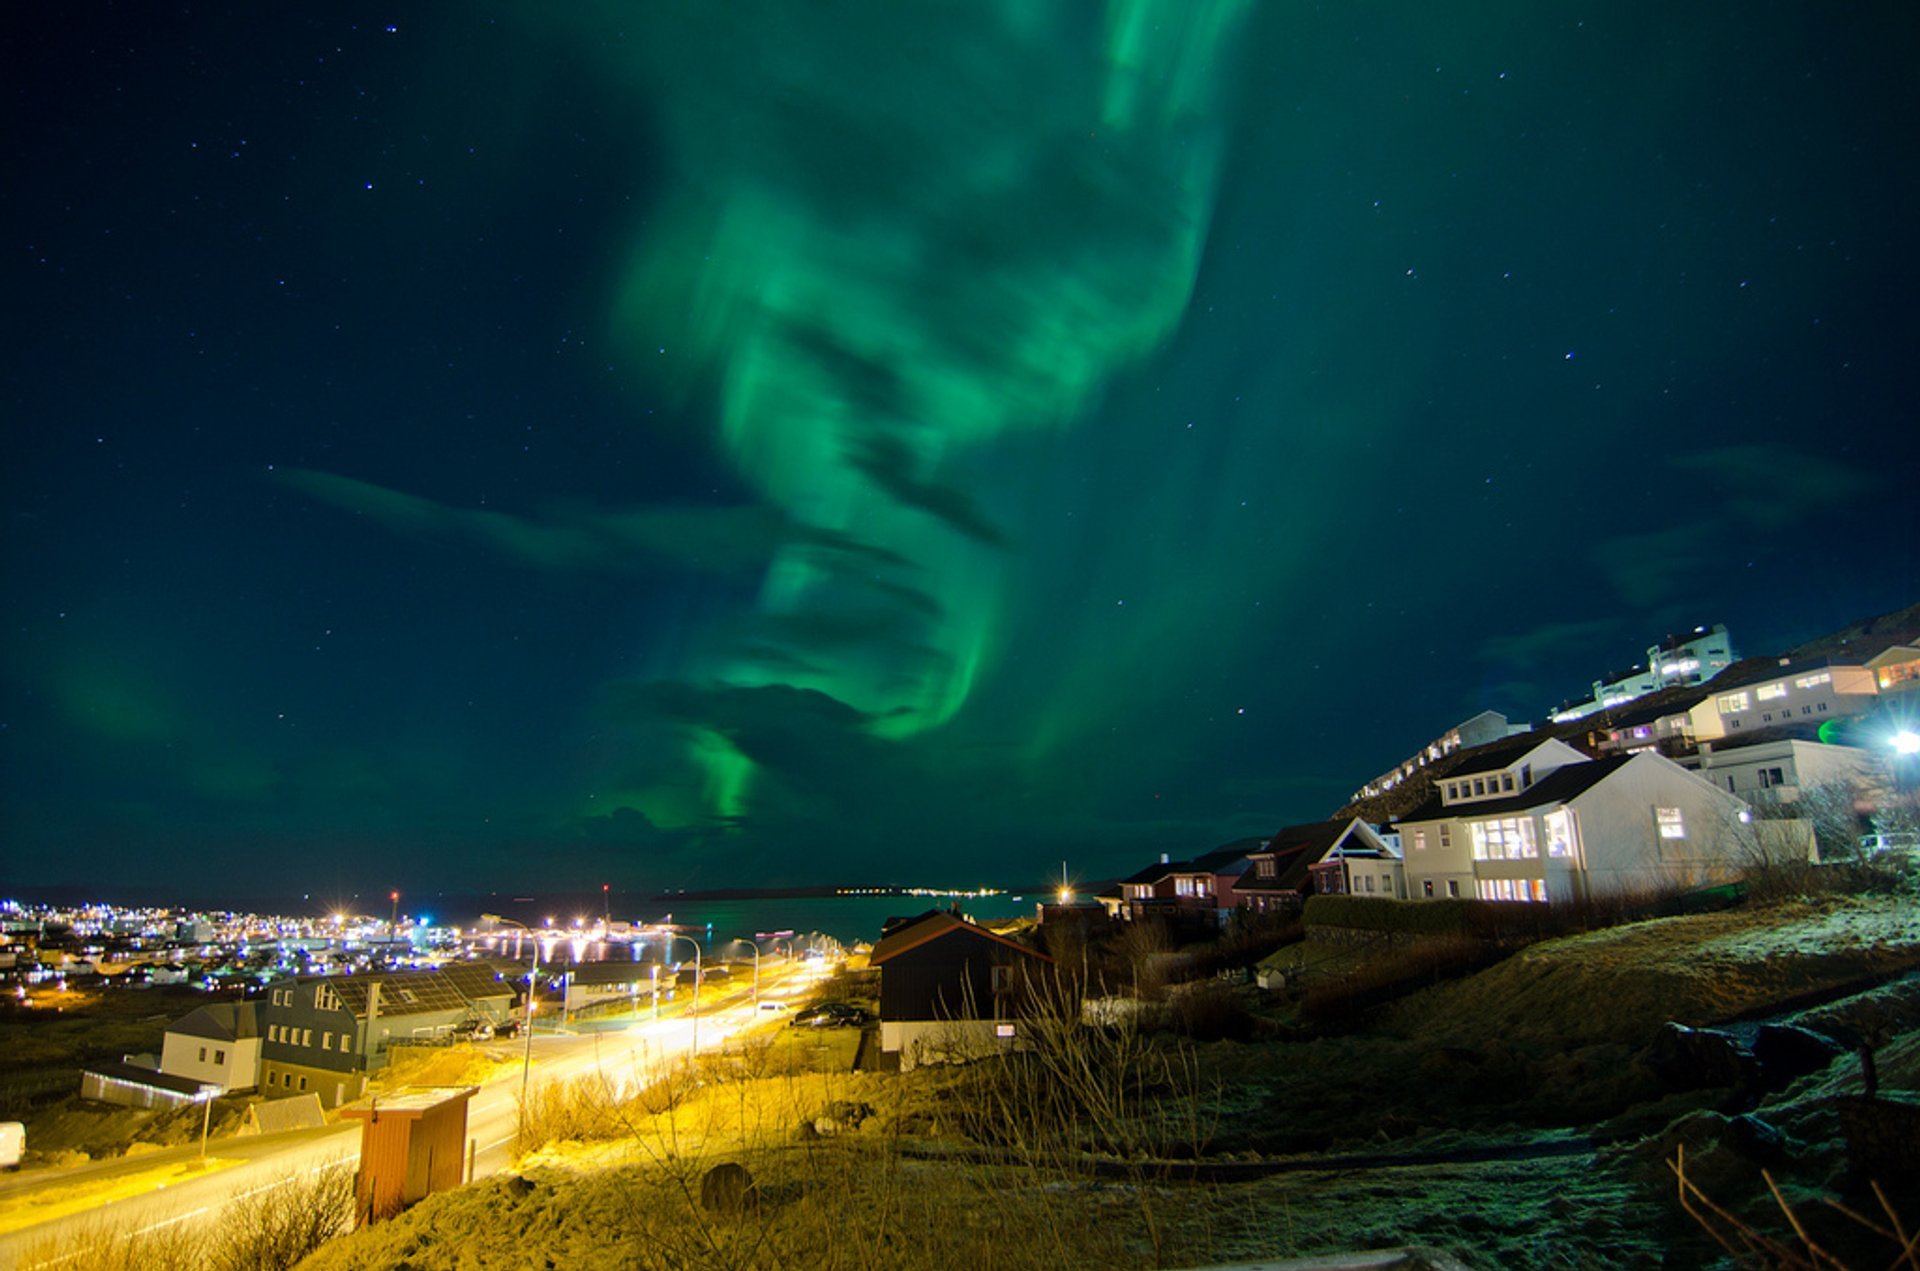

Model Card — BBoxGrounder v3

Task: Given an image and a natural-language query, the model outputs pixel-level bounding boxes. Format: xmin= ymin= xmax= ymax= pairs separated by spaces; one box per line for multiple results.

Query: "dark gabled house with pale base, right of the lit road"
xmin=868 ymin=912 xmax=1052 ymax=1069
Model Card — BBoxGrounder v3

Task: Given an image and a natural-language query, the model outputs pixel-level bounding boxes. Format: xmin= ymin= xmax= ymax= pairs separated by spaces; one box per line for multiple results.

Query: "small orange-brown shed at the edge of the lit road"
xmin=340 ymin=1085 xmax=480 ymax=1227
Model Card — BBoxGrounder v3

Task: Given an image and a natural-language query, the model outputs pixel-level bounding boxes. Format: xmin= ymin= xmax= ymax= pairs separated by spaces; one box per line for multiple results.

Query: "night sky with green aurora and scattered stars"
xmin=0 ymin=0 xmax=1920 ymax=895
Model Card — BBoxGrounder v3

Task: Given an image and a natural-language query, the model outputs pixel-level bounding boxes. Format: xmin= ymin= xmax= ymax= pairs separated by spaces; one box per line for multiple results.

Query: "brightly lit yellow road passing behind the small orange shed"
xmin=0 ymin=966 xmax=822 ymax=1271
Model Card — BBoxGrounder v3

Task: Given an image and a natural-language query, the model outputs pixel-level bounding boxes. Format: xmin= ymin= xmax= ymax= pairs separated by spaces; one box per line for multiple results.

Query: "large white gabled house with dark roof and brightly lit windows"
xmin=1398 ymin=747 xmax=1753 ymax=902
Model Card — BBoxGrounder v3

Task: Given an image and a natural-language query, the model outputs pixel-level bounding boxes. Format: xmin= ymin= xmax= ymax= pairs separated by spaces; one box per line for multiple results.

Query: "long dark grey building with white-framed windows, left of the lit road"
xmin=259 ymin=962 xmax=515 ymax=1108
